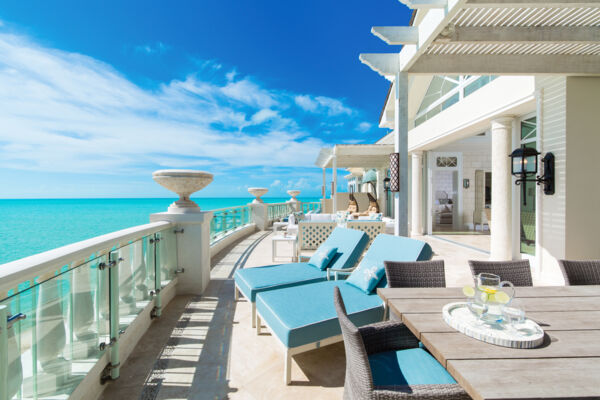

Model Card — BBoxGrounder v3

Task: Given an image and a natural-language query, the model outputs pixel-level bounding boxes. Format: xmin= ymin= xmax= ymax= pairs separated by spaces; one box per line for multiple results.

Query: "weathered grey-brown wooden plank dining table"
xmin=377 ymin=286 xmax=600 ymax=400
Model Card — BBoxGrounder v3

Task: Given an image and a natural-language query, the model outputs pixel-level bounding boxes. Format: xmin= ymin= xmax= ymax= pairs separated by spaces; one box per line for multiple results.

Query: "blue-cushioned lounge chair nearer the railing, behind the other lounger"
xmin=234 ymin=228 xmax=369 ymax=328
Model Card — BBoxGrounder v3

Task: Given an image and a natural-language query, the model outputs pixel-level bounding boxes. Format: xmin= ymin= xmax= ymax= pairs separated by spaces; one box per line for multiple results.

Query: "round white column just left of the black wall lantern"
xmin=490 ymin=117 xmax=514 ymax=261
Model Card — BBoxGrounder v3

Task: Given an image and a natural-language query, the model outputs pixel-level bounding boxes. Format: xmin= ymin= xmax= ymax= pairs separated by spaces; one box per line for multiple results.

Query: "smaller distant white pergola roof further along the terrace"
xmin=315 ymin=144 xmax=394 ymax=168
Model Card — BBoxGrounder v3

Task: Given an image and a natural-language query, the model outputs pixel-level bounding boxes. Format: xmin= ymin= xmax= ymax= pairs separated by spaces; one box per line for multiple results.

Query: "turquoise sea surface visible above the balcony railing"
xmin=0 ymin=197 xmax=317 ymax=265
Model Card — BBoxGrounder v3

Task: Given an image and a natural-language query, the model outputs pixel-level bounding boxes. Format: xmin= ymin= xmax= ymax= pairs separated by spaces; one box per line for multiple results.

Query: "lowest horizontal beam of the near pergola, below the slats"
xmin=408 ymin=54 xmax=600 ymax=76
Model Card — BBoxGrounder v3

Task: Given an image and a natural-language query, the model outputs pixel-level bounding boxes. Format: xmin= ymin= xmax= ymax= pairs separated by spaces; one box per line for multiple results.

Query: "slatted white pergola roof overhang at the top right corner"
xmin=360 ymin=0 xmax=600 ymax=76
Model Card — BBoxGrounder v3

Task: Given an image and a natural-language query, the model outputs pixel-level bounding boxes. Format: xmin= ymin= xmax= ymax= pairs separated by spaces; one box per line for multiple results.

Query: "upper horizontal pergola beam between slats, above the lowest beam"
xmin=433 ymin=26 xmax=600 ymax=44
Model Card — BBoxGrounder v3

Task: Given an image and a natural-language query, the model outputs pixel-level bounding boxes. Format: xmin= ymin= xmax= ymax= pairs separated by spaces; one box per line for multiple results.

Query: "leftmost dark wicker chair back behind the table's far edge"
xmin=384 ymin=260 xmax=446 ymax=288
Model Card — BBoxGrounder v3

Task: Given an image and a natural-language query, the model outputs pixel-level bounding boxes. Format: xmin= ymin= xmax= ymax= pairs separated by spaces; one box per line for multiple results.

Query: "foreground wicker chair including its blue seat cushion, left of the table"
xmin=334 ymin=287 xmax=470 ymax=400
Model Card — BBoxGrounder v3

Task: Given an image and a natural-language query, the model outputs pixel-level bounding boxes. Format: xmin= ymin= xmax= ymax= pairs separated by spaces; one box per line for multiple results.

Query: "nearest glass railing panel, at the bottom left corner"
xmin=0 ymin=255 xmax=109 ymax=399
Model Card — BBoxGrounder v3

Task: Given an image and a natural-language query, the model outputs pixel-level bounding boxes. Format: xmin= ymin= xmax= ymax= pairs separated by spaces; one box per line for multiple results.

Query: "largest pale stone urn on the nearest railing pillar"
xmin=152 ymin=169 xmax=213 ymax=214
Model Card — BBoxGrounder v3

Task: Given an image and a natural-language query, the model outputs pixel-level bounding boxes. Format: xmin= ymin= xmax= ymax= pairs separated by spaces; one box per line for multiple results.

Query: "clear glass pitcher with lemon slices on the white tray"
xmin=469 ymin=272 xmax=515 ymax=323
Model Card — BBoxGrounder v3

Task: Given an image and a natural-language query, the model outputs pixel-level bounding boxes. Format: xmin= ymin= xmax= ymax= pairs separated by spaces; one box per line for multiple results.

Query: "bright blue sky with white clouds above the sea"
xmin=0 ymin=0 xmax=410 ymax=198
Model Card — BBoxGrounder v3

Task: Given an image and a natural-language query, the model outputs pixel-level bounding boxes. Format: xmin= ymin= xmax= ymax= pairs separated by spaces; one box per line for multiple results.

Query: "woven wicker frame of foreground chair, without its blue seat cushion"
xmin=334 ymin=287 xmax=470 ymax=400
